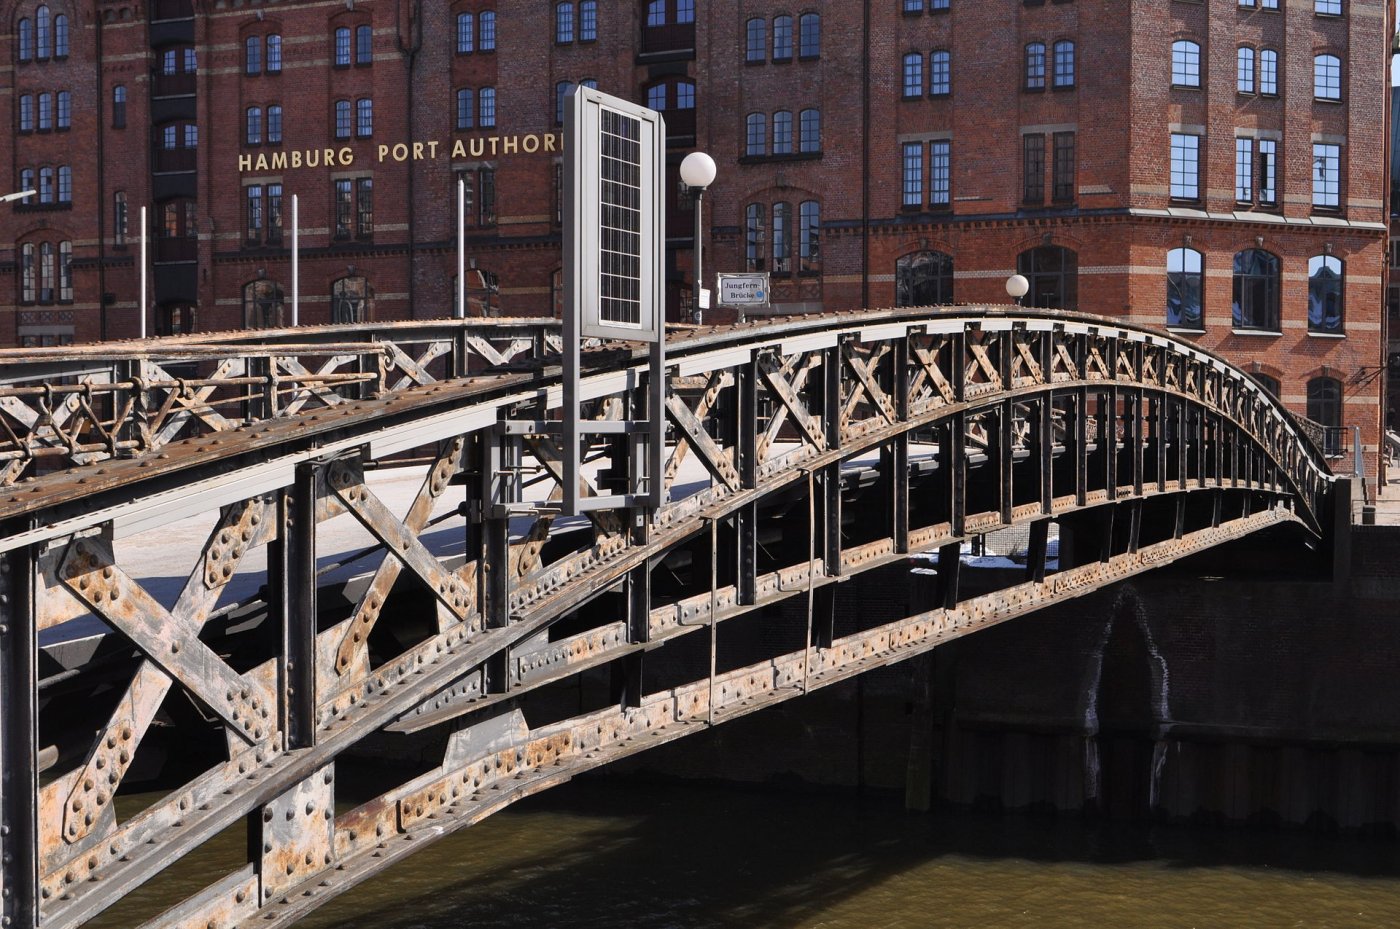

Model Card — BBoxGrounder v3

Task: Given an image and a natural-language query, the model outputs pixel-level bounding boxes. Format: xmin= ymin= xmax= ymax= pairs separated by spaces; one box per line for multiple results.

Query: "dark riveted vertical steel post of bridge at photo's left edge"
xmin=0 ymin=546 xmax=37 ymax=929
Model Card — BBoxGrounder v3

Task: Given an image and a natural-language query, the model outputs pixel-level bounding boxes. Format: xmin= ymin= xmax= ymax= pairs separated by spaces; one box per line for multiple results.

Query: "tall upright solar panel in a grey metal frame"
xmin=564 ymin=87 xmax=665 ymax=341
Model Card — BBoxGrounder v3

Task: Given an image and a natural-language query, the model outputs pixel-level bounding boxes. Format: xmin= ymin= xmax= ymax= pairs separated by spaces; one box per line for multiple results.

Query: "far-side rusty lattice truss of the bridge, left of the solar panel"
xmin=0 ymin=319 xmax=559 ymax=485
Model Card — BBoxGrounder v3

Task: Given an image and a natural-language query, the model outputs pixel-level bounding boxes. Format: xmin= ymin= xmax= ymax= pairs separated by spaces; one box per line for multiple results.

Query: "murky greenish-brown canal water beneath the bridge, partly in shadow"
xmin=98 ymin=778 xmax=1400 ymax=929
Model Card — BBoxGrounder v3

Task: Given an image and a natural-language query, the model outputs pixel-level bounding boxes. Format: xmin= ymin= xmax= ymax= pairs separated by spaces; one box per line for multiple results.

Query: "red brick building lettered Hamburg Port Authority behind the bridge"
xmin=0 ymin=0 xmax=1393 ymax=461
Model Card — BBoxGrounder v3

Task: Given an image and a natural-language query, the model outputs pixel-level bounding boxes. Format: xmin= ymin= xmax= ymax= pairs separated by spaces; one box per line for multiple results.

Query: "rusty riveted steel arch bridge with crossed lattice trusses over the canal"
xmin=0 ymin=308 xmax=1336 ymax=929
